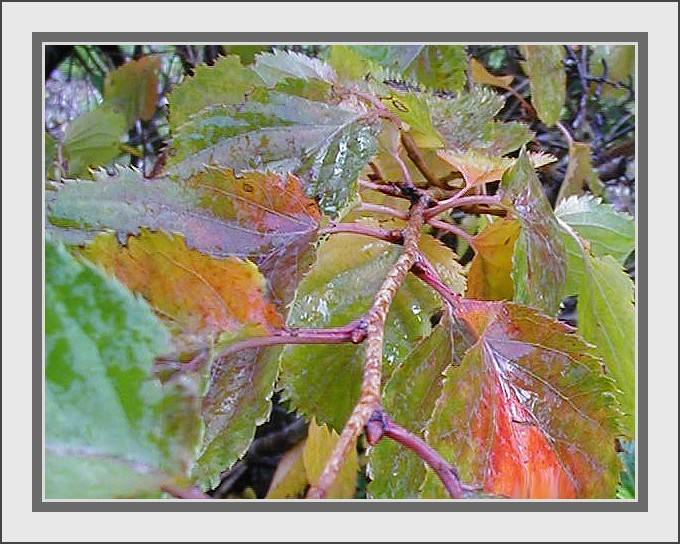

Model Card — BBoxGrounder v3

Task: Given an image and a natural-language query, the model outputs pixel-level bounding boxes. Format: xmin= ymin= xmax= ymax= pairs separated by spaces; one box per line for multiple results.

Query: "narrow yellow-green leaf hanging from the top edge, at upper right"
xmin=520 ymin=45 xmax=567 ymax=126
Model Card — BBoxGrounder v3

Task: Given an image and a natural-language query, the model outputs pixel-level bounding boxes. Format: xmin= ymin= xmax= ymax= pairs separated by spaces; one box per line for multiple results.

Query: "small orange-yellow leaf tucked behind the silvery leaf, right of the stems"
xmin=465 ymin=219 xmax=520 ymax=300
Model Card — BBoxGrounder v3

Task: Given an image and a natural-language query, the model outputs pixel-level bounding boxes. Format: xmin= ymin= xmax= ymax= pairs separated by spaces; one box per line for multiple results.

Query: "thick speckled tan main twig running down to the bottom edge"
xmin=307 ymin=197 xmax=427 ymax=499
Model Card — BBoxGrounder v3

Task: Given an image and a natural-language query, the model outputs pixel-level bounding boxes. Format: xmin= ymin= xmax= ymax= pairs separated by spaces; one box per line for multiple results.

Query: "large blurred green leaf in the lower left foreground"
xmin=45 ymin=240 xmax=200 ymax=499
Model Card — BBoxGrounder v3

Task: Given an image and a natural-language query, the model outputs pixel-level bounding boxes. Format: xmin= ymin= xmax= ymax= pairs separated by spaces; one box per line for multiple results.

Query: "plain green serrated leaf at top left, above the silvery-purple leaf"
xmin=168 ymin=55 xmax=264 ymax=132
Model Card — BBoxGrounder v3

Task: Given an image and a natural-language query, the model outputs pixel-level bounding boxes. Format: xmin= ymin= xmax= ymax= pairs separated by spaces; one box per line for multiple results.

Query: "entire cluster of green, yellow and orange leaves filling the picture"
xmin=45 ymin=45 xmax=635 ymax=498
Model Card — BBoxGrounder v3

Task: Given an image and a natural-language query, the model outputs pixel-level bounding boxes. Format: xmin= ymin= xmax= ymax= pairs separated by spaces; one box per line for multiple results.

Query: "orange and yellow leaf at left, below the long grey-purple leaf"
xmin=82 ymin=230 xmax=283 ymax=349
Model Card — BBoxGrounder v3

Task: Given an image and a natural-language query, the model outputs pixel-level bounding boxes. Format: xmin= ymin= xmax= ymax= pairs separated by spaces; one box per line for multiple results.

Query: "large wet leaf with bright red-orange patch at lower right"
xmin=423 ymin=299 xmax=620 ymax=499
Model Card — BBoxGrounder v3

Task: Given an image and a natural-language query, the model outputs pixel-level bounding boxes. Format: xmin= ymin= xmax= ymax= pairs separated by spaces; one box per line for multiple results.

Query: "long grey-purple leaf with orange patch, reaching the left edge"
xmin=47 ymin=168 xmax=320 ymax=301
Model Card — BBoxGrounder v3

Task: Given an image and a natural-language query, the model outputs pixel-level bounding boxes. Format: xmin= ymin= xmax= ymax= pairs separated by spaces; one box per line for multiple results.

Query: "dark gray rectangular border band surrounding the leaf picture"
xmin=32 ymin=32 xmax=649 ymax=512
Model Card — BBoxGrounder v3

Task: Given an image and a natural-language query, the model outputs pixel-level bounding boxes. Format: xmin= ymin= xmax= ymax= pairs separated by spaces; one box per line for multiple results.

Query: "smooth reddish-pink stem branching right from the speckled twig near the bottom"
xmin=366 ymin=410 xmax=468 ymax=499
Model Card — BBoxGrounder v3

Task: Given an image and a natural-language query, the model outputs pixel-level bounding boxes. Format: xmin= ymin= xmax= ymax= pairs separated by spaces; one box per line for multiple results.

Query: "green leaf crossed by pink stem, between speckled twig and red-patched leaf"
xmin=368 ymin=323 xmax=452 ymax=499
